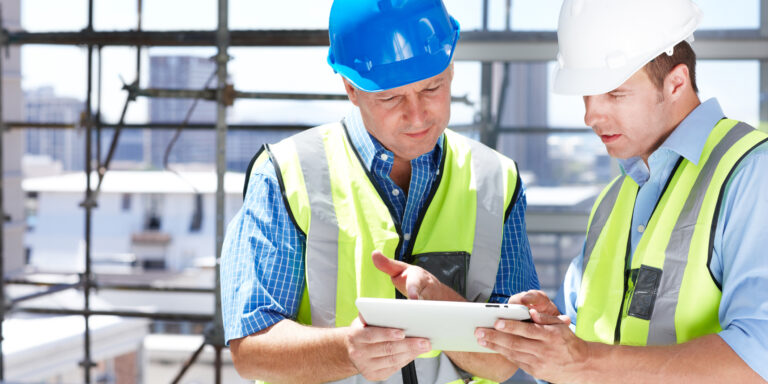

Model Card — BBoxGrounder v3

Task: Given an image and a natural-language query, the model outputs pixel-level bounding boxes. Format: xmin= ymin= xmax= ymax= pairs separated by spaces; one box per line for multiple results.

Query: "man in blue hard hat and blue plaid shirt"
xmin=216 ymin=0 xmax=539 ymax=384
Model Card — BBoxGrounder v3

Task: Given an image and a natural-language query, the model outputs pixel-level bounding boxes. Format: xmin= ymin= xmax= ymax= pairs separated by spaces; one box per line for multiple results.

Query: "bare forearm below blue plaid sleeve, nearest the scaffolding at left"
xmin=230 ymin=320 xmax=357 ymax=383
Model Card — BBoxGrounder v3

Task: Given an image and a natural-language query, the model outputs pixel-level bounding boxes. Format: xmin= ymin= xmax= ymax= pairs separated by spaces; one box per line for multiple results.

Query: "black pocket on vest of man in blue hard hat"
xmin=412 ymin=252 xmax=469 ymax=297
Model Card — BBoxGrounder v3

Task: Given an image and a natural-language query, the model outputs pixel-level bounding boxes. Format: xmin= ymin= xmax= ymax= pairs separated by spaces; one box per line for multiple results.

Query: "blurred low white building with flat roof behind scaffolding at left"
xmin=22 ymin=171 xmax=245 ymax=272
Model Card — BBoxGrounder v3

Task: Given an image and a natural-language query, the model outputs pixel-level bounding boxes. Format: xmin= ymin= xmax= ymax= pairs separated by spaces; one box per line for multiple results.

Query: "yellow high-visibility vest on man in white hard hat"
xmin=576 ymin=119 xmax=768 ymax=345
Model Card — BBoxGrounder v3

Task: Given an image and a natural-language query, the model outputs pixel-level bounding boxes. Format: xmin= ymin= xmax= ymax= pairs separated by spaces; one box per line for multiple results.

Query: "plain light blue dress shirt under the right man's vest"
xmin=555 ymin=99 xmax=768 ymax=380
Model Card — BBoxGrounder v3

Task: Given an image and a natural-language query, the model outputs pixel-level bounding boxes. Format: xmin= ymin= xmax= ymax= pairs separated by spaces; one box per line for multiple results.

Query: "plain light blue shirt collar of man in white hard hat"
xmin=618 ymin=98 xmax=725 ymax=185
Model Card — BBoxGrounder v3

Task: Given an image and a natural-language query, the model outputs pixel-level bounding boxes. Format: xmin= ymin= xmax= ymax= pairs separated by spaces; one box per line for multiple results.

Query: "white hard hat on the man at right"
xmin=554 ymin=0 xmax=701 ymax=96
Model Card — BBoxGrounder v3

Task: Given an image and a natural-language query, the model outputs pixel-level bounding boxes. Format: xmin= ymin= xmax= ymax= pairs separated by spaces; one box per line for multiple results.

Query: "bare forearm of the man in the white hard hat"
xmin=574 ymin=335 xmax=765 ymax=383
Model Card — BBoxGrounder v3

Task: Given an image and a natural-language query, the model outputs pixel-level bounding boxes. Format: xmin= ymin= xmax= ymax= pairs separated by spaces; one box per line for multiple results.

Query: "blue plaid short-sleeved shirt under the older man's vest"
xmin=221 ymin=108 xmax=539 ymax=342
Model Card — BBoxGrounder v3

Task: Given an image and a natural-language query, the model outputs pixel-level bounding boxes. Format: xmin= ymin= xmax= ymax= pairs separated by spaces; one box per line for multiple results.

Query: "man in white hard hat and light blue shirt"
xmin=476 ymin=0 xmax=768 ymax=383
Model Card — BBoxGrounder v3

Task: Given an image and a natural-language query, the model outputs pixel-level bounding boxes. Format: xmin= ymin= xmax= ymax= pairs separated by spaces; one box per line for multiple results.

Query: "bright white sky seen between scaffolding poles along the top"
xmin=16 ymin=0 xmax=759 ymax=127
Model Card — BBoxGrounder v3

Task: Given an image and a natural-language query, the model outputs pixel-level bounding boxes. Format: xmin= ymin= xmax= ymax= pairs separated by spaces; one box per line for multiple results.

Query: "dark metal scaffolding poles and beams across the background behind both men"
xmin=0 ymin=0 xmax=768 ymax=383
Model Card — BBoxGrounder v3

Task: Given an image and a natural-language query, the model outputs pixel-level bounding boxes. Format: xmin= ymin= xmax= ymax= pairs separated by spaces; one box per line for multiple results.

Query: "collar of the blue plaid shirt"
xmin=344 ymin=107 xmax=445 ymax=171
